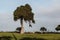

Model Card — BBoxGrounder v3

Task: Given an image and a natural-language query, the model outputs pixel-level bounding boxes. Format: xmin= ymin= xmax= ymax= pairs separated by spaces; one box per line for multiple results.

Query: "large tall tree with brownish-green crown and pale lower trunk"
xmin=13 ymin=4 xmax=35 ymax=34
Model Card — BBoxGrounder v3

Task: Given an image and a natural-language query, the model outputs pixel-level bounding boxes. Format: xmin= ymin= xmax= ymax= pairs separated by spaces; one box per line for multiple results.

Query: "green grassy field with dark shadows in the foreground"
xmin=0 ymin=33 xmax=60 ymax=40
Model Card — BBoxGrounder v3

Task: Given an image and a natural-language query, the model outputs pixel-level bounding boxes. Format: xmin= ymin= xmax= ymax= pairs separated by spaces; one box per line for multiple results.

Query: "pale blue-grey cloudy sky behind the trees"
xmin=0 ymin=0 xmax=60 ymax=31
